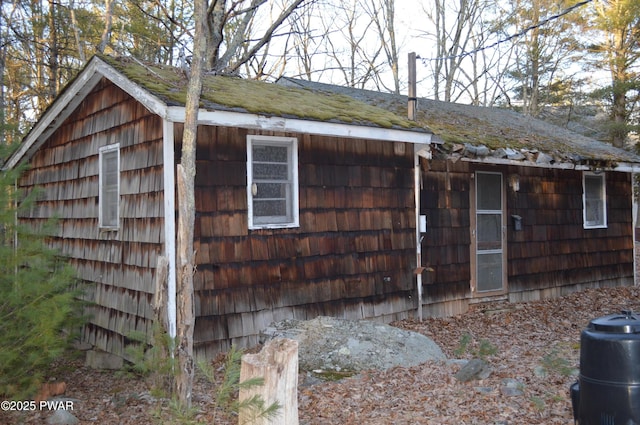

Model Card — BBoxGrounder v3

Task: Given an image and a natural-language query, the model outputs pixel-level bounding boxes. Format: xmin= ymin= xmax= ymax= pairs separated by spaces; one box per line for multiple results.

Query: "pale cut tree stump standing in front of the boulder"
xmin=238 ymin=338 xmax=298 ymax=425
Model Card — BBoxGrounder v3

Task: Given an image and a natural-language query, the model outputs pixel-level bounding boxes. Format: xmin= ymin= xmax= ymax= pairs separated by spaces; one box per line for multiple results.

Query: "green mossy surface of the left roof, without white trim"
xmin=101 ymin=56 xmax=421 ymax=129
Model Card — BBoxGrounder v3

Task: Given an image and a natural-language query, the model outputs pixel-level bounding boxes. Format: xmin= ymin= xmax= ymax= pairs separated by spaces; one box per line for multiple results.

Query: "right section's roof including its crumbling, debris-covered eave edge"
xmin=278 ymin=77 xmax=640 ymax=171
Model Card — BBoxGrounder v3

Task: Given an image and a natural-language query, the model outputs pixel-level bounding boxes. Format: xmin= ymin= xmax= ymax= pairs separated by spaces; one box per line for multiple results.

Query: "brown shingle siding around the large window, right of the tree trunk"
xmin=181 ymin=126 xmax=415 ymax=356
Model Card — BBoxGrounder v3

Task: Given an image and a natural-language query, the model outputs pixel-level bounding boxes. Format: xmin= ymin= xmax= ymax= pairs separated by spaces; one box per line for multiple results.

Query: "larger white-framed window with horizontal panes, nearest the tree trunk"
xmin=247 ymin=136 xmax=299 ymax=229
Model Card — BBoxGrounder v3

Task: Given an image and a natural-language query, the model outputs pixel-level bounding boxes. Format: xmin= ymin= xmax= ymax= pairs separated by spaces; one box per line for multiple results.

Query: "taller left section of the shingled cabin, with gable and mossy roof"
xmin=4 ymin=57 xmax=431 ymax=357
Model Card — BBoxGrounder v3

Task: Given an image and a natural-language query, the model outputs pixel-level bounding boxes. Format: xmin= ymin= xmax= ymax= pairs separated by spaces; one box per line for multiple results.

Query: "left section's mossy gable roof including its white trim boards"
xmin=2 ymin=55 xmax=431 ymax=169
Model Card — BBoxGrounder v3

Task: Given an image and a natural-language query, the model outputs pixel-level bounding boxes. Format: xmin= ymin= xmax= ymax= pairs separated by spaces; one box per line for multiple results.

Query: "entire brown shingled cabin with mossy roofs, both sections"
xmin=4 ymin=56 xmax=640 ymax=357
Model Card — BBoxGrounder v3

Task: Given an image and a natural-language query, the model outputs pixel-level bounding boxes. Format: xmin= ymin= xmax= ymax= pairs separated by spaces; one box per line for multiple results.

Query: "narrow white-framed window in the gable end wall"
xmin=98 ymin=144 xmax=120 ymax=229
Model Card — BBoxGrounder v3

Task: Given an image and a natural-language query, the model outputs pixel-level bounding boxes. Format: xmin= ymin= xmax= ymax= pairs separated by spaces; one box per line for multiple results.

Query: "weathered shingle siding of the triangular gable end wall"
xmin=20 ymin=80 xmax=164 ymax=355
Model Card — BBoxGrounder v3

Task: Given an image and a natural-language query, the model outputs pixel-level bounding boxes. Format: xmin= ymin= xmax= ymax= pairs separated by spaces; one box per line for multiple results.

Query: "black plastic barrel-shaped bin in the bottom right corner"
xmin=571 ymin=311 xmax=640 ymax=425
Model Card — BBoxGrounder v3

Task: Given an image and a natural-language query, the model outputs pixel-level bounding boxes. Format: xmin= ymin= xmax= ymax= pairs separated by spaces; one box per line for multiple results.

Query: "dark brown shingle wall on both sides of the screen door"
xmin=421 ymin=159 xmax=633 ymax=315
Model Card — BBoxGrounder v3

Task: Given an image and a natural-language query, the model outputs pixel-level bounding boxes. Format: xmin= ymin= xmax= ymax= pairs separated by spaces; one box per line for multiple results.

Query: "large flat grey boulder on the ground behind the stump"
xmin=263 ymin=316 xmax=446 ymax=372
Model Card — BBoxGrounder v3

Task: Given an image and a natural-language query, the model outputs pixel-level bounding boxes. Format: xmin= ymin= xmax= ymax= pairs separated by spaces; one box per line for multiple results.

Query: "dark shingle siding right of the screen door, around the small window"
xmin=505 ymin=167 xmax=633 ymax=301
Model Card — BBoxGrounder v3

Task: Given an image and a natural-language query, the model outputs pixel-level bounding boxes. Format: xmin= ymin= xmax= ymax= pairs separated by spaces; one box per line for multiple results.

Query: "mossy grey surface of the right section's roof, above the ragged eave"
xmin=281 ymin=78 xmax=640 ymax=163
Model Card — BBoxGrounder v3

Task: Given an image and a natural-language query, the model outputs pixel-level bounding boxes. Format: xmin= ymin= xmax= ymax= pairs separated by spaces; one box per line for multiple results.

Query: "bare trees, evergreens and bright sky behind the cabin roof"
xmin=0 ymin=0 xmax=640 ymax=146
